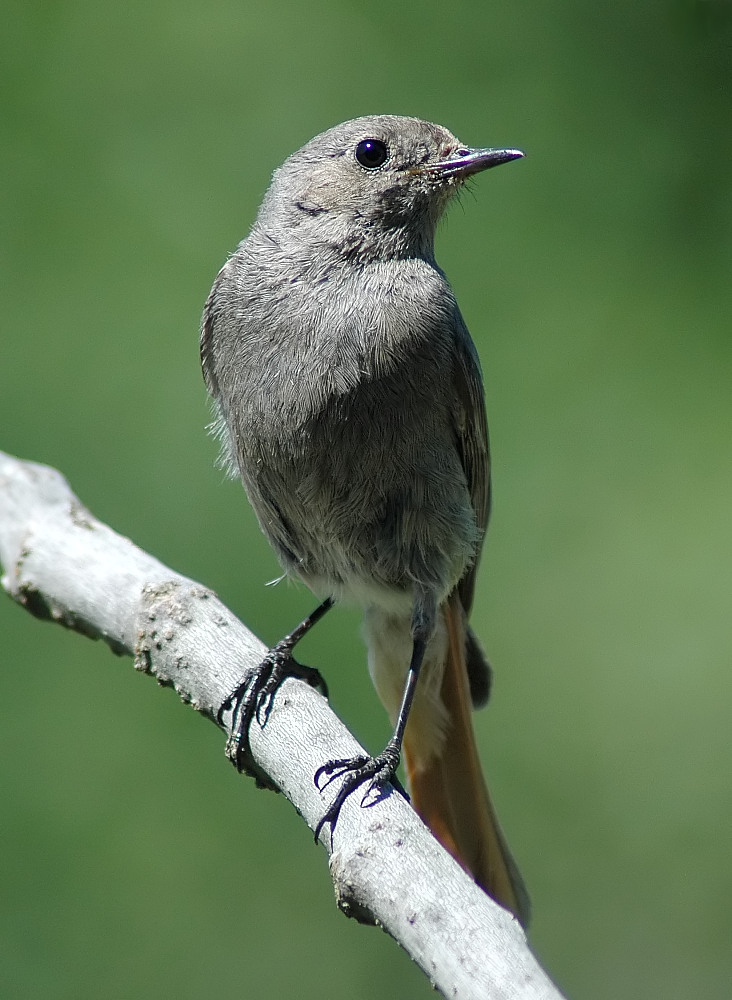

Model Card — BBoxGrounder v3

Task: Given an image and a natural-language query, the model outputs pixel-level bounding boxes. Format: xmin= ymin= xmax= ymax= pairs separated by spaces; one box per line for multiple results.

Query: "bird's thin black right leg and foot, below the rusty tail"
xmin=314 ymin=595 xmax=435 ymax=840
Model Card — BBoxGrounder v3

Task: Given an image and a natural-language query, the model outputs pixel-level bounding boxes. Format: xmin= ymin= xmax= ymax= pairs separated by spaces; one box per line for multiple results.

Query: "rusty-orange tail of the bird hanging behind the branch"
xmin=403 ymin=593 xmax=529 ymax=926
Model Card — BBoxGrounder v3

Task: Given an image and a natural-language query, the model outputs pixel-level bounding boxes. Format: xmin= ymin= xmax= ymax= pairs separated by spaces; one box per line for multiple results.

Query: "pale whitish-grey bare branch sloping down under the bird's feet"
xmin=0 ymin=452 xmax=562 ymax=1000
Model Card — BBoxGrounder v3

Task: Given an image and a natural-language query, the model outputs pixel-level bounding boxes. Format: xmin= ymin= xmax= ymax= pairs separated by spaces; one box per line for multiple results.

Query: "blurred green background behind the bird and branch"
xmin=0 ymin=0 xmax=732 ymax=1000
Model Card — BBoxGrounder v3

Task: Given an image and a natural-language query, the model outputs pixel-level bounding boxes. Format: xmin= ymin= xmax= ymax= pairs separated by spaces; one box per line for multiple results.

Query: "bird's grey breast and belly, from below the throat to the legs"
xmin=213 ymin=249 xmax=477 ymax=595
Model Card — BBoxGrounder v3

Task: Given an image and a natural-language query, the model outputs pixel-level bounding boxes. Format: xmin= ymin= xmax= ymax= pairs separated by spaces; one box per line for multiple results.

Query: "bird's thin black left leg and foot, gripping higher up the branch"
xmin=216 ymin=597 xmax=334 ymax=783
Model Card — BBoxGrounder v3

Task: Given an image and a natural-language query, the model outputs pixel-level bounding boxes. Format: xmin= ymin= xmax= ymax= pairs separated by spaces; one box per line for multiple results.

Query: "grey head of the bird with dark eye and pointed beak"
xmin=259 ymin=115 xmax=524 ymax=258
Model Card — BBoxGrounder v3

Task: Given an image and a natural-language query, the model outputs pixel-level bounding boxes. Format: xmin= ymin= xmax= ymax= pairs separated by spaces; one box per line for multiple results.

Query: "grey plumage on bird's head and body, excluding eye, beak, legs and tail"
xmin=202 ymin=116 xmax=488 ymax=606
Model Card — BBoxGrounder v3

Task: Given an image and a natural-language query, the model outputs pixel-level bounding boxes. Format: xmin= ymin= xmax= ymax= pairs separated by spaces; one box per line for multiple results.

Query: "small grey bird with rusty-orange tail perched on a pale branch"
xmin=201 ymin=115 xmax=529 ymax=923
